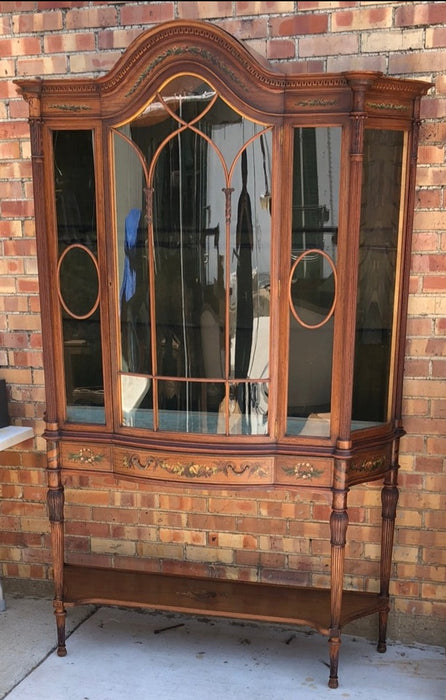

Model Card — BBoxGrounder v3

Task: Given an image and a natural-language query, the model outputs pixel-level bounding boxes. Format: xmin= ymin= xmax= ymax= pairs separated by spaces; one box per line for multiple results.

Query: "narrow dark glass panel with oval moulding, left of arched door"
xmin=53 ymin=131 xmax=105 ymax=424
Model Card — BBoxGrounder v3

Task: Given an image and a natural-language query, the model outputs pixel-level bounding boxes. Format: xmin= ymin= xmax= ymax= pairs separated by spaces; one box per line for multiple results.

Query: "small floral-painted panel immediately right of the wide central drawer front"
xmin=276 ymin=456 xmax=333 ymax=486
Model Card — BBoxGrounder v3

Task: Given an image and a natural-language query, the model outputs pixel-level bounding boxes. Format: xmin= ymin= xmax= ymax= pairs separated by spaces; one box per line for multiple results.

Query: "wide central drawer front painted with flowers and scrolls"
xmin=113 ymin=449 xmax=273 ymax=486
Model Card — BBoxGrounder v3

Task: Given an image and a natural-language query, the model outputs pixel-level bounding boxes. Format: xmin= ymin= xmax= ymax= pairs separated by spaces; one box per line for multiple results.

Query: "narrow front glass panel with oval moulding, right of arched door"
xmin=287 ymin=127 xmax=341 ymax=437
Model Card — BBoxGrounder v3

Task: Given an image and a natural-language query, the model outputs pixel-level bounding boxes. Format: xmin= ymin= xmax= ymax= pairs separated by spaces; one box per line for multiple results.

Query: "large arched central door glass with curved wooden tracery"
xmin=113 ymin=75 xmax=271 ymax=435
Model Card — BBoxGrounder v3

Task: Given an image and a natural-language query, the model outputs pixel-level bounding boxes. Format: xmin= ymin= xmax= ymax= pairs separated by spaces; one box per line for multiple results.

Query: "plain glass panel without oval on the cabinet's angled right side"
xmin=352 ymin=129 xmax=404 ymax=429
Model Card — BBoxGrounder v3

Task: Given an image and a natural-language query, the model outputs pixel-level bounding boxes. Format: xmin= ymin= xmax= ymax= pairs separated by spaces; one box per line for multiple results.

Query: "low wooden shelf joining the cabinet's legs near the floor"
xmin=64 ymin=565 xmax=388 ymax=635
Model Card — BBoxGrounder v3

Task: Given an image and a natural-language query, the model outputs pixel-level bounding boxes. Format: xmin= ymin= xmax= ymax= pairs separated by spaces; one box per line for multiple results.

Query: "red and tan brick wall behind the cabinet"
xmin=0 ymin=0 xmax=446 ymax=643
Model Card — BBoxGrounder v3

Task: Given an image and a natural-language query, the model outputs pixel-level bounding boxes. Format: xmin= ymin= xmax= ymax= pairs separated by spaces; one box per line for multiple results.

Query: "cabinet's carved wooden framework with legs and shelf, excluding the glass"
xmin=17 ymin=21 xmax=429 ymax=688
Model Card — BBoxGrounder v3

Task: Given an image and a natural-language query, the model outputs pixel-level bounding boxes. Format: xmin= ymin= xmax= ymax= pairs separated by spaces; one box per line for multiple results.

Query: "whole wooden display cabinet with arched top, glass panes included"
xmin=17 ymin=21 xmax=429 ymax=688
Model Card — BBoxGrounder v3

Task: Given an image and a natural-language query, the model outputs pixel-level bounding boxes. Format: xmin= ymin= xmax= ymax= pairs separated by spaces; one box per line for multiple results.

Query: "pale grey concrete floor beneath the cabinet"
xmin=0 ymin=595 xmax=446 ymax=700
